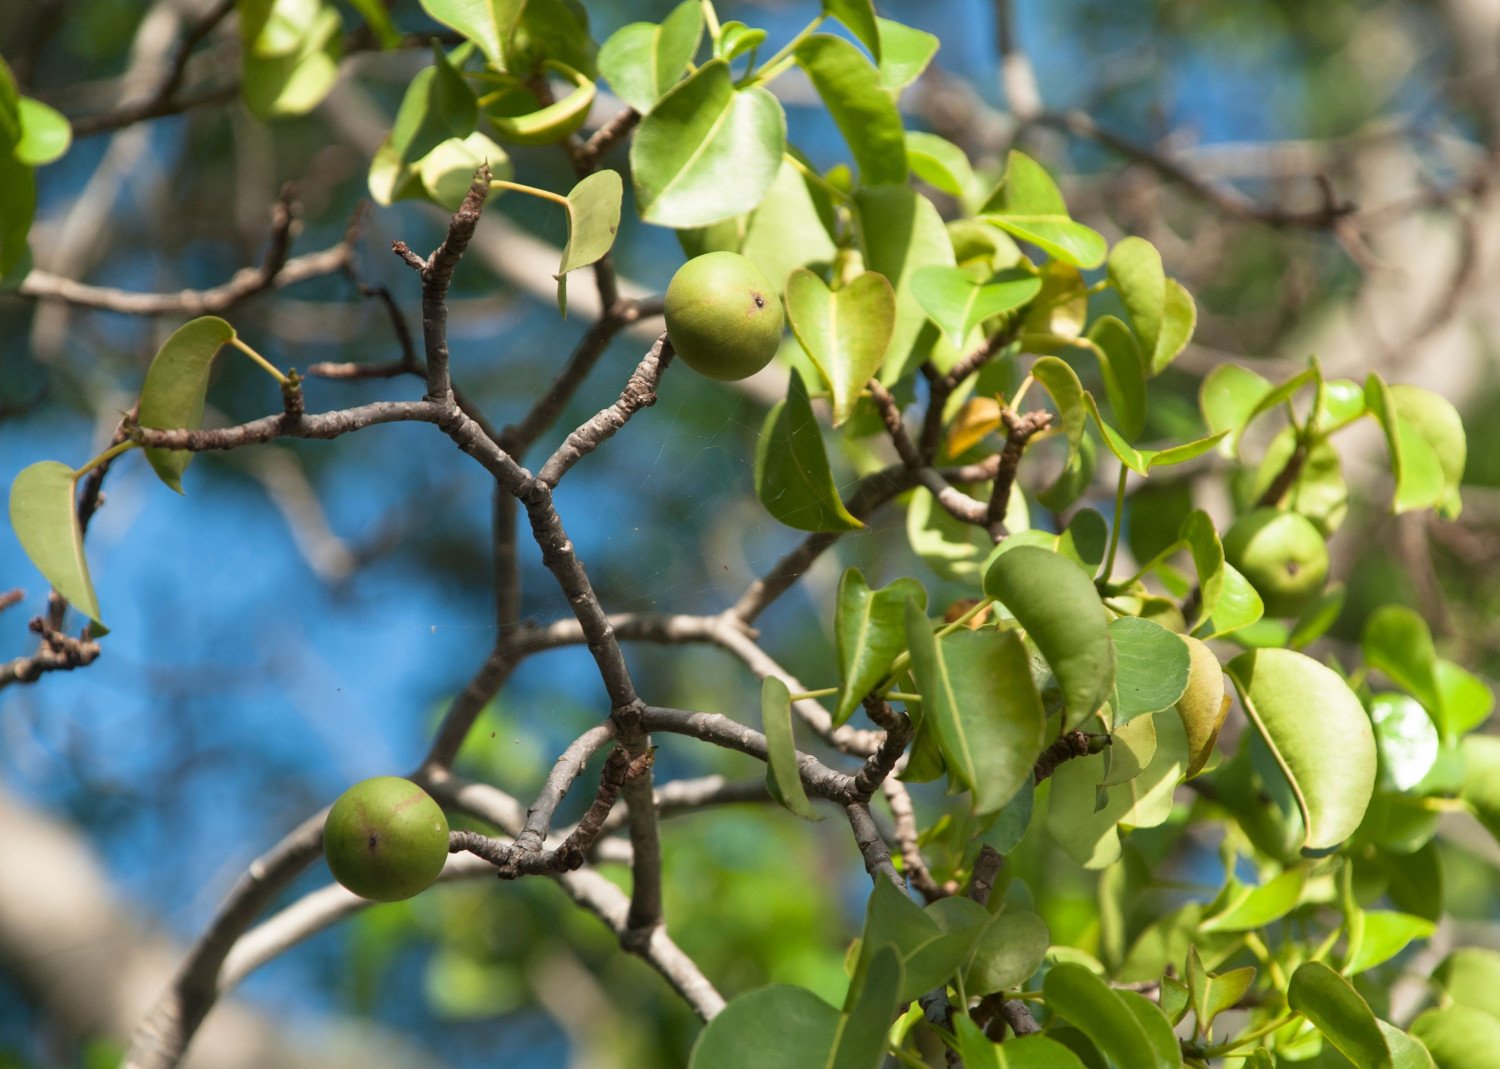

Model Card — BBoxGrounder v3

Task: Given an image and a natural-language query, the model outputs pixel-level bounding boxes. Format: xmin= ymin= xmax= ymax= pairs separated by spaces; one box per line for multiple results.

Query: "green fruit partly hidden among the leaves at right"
xmin=1224 ymin=508 xmax=1328 ymax=616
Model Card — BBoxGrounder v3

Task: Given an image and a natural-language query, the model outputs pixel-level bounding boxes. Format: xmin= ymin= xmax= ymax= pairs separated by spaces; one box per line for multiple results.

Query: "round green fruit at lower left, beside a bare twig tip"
xmin=323 ymin=775 xmax=449 ymax=903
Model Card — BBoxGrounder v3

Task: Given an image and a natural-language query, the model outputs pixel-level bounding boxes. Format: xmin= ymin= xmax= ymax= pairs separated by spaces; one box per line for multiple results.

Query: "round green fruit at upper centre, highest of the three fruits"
xmin=665 ymin=252 xmax=782 ymax=381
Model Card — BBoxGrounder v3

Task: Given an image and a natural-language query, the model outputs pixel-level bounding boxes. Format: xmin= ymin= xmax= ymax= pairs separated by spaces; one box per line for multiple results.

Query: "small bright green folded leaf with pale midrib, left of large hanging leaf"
xmin=834 ymin=568 xmax=927 ymax=726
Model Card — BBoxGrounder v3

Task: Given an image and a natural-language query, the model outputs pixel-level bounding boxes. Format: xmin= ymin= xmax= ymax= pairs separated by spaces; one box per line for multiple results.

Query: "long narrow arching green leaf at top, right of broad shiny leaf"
xmin=797 ymin=33 xmax=908 ymax=186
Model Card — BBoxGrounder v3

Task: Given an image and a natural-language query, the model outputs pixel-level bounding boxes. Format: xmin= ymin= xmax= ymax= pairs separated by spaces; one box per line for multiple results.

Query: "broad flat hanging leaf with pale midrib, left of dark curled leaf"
xmin=906 ymin=605 xmax=1047 ymax=816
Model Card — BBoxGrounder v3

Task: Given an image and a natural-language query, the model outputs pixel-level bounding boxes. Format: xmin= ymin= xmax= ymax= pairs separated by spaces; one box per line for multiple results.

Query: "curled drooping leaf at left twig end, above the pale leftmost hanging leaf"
xmin=138 ymin=315 xmax=234 ymax=493
